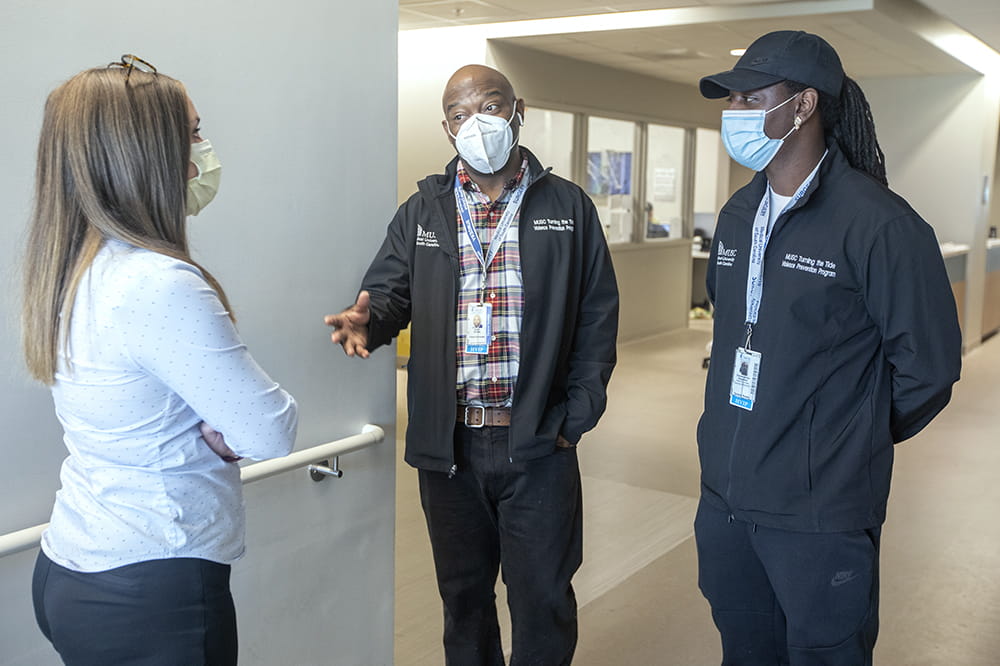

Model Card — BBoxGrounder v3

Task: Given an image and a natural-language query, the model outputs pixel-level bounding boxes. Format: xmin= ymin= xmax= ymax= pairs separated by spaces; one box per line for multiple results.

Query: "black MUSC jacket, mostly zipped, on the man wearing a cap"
xmin=698 ymin=145 xmax=962 ymax=532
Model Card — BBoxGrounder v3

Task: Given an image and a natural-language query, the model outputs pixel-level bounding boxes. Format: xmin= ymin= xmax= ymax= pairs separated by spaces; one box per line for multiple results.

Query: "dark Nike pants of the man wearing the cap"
xmin=694 ymin=500 xmax=881 ymax=666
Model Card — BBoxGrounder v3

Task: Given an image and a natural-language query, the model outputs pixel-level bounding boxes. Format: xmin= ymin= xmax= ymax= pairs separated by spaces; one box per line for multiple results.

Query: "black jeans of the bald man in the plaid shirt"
xmin=419 ymin=425 xmax=583 ymax=666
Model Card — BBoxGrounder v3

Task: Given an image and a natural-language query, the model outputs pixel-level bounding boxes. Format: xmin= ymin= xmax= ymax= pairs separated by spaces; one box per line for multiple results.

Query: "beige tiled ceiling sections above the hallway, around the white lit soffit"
xmin=400 ymin=0 xmax=1000 ymax=83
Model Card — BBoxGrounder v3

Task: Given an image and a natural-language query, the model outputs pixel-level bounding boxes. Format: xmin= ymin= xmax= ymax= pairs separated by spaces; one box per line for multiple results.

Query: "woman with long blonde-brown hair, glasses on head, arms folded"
xmin=23 ymin=56 xmax=297 ymax=666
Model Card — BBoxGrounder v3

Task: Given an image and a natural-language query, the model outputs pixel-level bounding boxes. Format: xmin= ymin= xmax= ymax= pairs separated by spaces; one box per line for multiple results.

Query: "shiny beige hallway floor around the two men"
xmin=395 ymin=322 xmax=1000 ymax=666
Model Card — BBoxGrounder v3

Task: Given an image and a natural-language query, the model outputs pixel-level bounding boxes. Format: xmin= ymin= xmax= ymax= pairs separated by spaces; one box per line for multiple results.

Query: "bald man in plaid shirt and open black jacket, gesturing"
xmin=326 ymin=65 xmax=618 ymax=666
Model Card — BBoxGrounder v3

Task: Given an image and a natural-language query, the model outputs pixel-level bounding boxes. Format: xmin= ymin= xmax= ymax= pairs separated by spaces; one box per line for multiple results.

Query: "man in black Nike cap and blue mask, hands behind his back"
xmin=695 ymin=31 xmax=961 ymax=666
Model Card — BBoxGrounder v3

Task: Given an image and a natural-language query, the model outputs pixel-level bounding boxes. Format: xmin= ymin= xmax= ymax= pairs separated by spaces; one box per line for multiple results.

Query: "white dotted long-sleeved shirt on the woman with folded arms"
xmin=42 ymin=241 xmax=297 ymax=571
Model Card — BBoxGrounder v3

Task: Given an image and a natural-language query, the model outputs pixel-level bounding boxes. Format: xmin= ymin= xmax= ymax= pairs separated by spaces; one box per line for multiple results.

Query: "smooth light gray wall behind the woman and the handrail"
xmin=0 ymin=0 xmax=397 ymax=666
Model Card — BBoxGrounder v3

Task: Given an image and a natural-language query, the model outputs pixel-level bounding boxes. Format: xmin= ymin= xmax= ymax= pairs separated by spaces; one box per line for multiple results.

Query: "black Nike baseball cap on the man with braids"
xmin=699 ymin=30 xmax=844 ymax=99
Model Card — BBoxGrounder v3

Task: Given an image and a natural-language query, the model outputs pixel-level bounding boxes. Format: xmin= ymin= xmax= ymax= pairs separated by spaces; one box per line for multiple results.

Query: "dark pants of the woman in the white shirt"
xmin=31 ymin=552 xmax=237 ymax=666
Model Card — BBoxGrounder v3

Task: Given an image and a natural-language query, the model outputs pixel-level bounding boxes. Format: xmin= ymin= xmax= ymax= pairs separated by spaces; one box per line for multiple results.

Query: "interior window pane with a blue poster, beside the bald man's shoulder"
xmin=585 ymin=116 xmax=636 ymax=243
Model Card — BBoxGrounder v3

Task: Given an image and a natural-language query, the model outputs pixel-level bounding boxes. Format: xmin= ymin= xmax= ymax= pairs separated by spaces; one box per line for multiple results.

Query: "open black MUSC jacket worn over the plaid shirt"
xmin=361 ymin=148 xmax=618 ymax=472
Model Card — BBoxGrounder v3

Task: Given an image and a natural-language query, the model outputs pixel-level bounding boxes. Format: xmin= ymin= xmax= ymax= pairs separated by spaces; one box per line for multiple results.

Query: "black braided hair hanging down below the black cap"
xmin=785 ymin=76 xmax=889 ymax=185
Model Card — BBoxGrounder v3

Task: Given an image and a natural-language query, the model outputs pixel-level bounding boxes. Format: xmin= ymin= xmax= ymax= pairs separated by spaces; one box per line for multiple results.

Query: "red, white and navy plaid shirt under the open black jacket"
xmin=456 ymin=159 xmax=528 ymax=407
